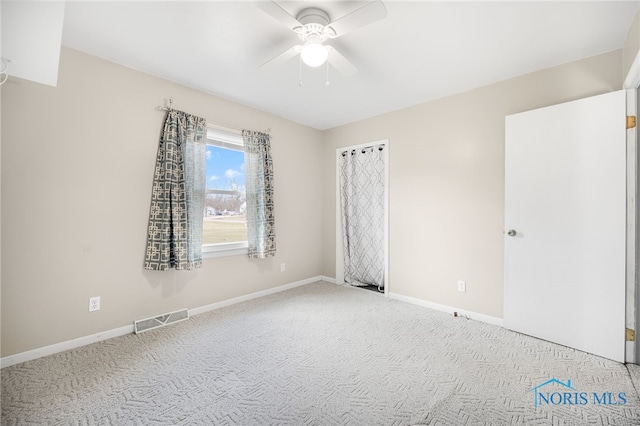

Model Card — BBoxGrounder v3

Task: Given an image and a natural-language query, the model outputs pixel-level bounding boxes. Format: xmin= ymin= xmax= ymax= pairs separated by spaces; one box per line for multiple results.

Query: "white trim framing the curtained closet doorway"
xmin=335 ymin=139 xmax=390 ymax=297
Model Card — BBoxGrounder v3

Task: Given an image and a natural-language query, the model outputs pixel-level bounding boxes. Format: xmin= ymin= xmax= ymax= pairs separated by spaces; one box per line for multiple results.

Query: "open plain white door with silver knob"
xmin=504 ymin=91 xmax=626 ymax=362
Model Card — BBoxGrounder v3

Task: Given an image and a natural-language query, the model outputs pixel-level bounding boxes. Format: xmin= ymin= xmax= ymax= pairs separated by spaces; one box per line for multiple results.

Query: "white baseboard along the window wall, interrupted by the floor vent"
xmin=0 ymin=276 xmax=326 ymax=368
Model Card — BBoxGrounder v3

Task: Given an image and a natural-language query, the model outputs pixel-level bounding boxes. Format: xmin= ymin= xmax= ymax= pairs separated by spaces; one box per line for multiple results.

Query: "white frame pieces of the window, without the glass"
xmin=202 ymin=125 xmax=249 ymax=259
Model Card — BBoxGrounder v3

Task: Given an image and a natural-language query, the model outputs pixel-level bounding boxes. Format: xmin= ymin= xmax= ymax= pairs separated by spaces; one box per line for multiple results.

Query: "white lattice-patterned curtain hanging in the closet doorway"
xmin=339 ymin=145 xmax=385 ymax=290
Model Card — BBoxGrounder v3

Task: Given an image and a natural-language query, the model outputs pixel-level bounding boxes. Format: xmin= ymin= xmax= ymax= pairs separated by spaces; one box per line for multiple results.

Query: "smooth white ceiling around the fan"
xmin=62 ymin=0 xmax=640 ymax=129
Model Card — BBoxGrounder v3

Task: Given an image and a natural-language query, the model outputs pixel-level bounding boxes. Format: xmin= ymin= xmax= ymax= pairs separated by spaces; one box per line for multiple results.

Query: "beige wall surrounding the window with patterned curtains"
xmin=1 ymin=48 xmax=322 ymax=356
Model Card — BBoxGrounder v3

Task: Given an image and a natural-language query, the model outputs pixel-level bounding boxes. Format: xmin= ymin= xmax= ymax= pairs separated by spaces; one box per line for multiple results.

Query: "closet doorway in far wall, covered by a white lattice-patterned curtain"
xmin=336 ymin=140 xmax=389 ymax=296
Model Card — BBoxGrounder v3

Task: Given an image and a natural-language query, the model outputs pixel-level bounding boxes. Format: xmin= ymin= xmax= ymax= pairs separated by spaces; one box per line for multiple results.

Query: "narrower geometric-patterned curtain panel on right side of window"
xmin=242 ymin=130 xmax=276 ymax=259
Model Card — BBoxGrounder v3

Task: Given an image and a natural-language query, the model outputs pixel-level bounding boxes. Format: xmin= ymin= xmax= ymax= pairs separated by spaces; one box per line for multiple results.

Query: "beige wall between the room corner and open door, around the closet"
xmin=322 ymin=50 xmax=622 ymax=318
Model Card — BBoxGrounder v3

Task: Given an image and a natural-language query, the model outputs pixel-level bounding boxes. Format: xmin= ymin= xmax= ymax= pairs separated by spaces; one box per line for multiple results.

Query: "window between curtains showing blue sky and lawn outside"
xmin=202 ymin=128 xmax=248 ymax=257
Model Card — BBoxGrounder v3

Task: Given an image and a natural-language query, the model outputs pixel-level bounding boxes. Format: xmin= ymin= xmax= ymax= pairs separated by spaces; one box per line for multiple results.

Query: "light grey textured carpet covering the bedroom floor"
xmin=1 ymin=282 xmax=640 ymax=425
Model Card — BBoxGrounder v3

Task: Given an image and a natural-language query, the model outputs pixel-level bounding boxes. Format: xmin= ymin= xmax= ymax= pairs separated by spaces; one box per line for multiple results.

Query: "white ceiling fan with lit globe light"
xmin=257 ymin=0 xmax=387 ymax=76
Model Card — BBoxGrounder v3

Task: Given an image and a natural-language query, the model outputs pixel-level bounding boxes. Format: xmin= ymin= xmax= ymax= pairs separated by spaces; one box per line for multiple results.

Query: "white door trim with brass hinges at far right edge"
xmin=622 ymin=51 xmax=640 ymax=364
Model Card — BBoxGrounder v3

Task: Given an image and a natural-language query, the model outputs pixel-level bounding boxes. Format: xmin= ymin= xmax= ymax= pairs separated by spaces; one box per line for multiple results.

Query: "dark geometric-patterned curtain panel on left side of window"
xmin=144 ymin=110 xmax=207 ymax=271
